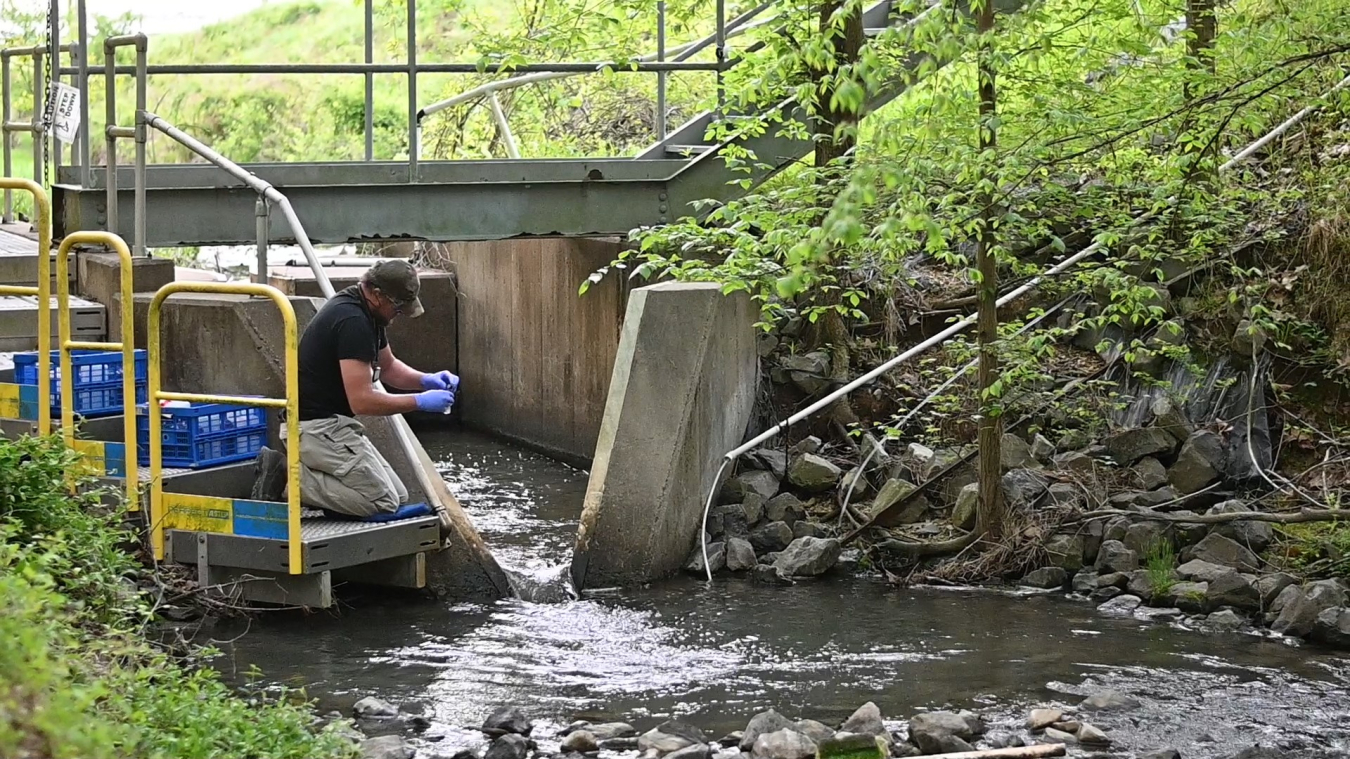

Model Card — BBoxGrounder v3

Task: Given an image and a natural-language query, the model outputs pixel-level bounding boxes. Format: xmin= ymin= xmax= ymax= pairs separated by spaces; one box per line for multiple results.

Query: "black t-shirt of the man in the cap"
xmin=298 ymin=285 xmax=389 ymax=421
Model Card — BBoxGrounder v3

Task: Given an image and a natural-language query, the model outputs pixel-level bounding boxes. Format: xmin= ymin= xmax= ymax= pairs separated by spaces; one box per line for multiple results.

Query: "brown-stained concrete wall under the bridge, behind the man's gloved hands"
xmin=433 ymin=238 xmax=629 ymax=466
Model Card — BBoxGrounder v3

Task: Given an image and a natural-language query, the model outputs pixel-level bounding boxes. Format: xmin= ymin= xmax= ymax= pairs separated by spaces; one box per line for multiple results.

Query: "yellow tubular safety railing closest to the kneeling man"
xmin=147 ymin=282 xmax=304 ymax=574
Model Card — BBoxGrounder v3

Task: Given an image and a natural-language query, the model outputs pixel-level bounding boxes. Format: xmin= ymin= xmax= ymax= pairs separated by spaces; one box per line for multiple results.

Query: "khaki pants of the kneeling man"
xmin=281 ymin=416 xmax=408 ymax=517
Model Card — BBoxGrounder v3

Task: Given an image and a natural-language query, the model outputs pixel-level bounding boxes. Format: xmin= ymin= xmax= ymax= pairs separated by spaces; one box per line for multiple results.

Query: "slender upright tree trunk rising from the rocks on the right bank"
xmin=975 ymin=0 xmax=1004 ymax=539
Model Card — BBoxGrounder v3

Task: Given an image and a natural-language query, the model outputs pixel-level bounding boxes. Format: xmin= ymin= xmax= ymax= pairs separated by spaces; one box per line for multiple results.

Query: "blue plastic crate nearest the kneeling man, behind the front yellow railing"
xmin=136 ymin=404 xmax=267 ymax=469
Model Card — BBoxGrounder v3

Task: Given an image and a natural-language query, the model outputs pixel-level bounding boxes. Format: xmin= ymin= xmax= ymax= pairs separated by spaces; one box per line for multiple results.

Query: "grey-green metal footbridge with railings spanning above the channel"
xmin=5 ymin=0 xmax=972 ymax=245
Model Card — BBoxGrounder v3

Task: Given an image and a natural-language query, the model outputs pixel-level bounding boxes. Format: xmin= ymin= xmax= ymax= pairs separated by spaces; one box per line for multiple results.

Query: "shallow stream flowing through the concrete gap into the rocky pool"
xmin=215 ymin=432 xmax=1350 ymax=759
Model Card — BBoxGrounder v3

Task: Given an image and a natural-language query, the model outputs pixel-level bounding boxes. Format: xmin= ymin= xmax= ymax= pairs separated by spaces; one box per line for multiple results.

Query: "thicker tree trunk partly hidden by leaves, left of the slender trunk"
xmin=813 ymin=0 xmax=864 ymax=427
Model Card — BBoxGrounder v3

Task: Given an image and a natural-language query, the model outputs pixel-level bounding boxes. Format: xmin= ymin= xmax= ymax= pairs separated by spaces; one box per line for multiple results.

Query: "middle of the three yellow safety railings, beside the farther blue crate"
xmin=57 ymin=226 xmax=140 ymax=512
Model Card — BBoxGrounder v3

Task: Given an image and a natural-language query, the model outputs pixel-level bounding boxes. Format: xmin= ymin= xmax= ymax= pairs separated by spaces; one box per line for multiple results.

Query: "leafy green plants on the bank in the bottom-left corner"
xmin=0 ymin=438 xmax=354 ymax=759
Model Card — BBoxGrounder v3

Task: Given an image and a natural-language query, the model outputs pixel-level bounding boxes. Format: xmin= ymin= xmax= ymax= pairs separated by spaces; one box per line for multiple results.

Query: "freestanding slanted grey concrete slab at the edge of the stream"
xmin=572 ymin=284 xmax=759 ymax=589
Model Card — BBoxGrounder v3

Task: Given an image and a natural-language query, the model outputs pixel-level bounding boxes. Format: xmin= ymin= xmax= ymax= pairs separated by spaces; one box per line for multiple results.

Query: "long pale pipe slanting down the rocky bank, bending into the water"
xmin=698 ymin=69 xmax=1350 ymax=582
